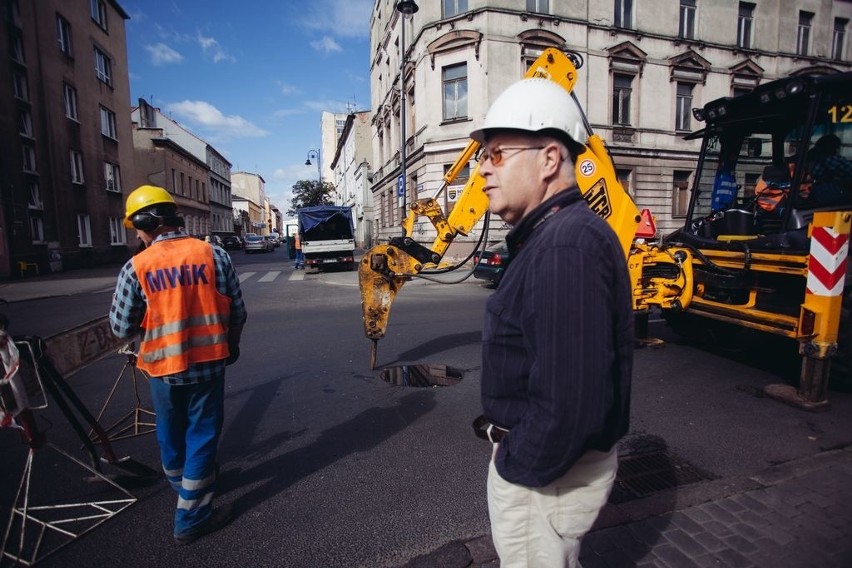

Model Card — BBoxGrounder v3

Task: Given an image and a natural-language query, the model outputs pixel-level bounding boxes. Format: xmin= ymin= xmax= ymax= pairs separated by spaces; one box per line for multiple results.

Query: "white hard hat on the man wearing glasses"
xmin=470 ymin=78 xmax=588 ymax=148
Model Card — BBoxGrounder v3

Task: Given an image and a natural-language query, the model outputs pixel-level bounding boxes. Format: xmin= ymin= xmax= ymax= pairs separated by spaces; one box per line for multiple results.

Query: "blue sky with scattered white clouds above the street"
xmin=119 ymin=0 xmax=374 ymax=212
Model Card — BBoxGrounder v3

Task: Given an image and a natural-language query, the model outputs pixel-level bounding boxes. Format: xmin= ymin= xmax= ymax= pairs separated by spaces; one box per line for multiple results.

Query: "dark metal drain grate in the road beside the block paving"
xmin=610 ymin=451 xmax=710 ymax=505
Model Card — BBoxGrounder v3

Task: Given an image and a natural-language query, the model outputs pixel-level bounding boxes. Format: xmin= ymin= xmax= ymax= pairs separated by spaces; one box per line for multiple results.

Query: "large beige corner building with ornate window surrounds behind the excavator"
xmin=370 ymin=0 xmax=852 ymax=252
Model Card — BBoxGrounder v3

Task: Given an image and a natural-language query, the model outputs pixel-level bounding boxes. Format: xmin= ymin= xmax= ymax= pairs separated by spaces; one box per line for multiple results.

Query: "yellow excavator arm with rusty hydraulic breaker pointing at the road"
xmin=358 ymin=48 xmax=640 ymax=368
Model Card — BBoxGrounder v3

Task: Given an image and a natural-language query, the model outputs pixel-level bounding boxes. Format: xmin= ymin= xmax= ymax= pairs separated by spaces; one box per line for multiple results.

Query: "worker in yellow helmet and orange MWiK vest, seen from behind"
xmin=109 ymin=185 xmax=246 ymax=544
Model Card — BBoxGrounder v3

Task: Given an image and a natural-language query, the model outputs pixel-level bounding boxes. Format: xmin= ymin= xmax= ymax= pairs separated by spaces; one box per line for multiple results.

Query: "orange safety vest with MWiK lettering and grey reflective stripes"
xmin=133 ymin=237 xmax=231 ymax=377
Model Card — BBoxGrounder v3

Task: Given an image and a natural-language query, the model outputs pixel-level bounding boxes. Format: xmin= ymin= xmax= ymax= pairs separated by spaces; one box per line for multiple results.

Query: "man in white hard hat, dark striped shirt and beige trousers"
xmin=471 ymin=79 xmax=633 ymax=568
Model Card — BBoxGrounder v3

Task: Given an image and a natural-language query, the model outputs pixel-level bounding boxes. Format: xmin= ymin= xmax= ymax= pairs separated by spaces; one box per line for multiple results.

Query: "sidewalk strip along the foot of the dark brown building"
xmin=0 ymin=265 xmax=121 ymax=303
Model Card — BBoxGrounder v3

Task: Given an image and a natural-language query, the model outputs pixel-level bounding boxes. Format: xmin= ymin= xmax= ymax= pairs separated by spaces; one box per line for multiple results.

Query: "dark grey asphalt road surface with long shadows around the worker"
xmin=0 ymin=249 xmax=852 ymax=568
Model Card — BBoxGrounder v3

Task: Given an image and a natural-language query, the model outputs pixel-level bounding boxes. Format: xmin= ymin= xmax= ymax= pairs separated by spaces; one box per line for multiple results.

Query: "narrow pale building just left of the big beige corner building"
xmin=331 ymin=111 xmax=373 ymax=248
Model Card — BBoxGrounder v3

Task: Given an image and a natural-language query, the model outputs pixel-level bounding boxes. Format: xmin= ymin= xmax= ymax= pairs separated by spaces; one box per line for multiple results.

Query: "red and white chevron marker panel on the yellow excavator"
xmin=808 ymin=227 xmax=849 ymax=296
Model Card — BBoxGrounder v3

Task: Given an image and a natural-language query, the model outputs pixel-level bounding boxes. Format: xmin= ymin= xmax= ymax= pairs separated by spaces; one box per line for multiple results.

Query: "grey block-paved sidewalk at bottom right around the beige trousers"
xmin=406 ymin=447 xmax=852 ymax=568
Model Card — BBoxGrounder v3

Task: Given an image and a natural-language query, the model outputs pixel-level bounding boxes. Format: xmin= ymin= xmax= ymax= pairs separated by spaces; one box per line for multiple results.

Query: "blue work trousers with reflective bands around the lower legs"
xmin=149 ymin=376 xmax=225 ymax=536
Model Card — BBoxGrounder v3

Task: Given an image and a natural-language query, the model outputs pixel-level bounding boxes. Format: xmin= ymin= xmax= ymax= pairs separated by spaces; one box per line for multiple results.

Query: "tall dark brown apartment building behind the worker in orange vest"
xmin=0 ymin=0 xmax=134 ymax=278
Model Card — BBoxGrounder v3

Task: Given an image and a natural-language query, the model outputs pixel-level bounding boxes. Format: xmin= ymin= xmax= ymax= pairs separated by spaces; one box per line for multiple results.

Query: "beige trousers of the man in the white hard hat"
xmin=488 ymin=448 xmax=618 ymax=568
